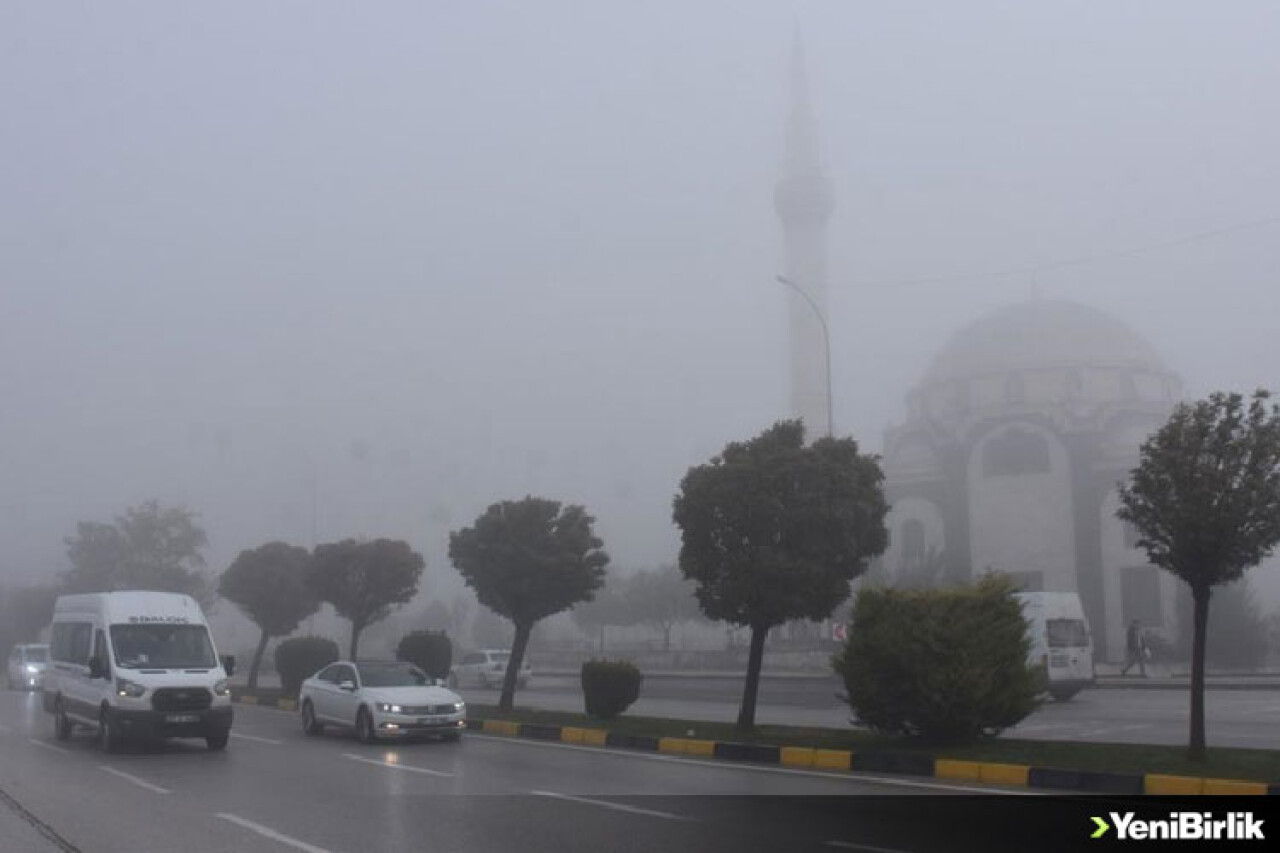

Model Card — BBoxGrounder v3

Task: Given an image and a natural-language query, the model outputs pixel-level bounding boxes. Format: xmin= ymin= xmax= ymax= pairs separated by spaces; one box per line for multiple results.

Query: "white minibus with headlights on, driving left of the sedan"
xmin=41 ymin=592 xmax=236 ymax=752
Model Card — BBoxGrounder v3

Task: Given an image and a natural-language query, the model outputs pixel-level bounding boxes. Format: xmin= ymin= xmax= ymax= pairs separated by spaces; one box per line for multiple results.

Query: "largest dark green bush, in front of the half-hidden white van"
xmin=832 ymin=575 xmax=1043 ymax=743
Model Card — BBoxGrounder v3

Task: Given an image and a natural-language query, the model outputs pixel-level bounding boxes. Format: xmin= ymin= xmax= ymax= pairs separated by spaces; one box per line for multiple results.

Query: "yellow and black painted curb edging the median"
xmin=232 ymin=693 xmax=1280 ymax=797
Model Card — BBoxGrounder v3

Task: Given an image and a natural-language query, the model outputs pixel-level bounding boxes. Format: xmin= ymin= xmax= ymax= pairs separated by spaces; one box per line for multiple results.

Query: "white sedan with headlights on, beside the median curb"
xmin=298 ymin=661 xmax=467 ymax=743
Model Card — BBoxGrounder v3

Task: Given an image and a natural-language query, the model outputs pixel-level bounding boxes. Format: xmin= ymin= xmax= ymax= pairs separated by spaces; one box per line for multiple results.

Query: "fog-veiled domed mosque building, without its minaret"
xmin=878 ymin=298 xmax=1181 ymax=660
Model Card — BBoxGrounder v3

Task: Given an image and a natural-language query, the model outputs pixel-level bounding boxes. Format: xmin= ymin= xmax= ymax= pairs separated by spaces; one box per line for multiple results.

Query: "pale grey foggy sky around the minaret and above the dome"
xmin=0 ymin=0 xmax=1280 ymax=604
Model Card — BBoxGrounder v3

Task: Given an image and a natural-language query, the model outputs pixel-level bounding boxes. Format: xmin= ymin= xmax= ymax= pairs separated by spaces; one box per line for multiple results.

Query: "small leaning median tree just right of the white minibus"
xmin=218 ymin=542 xmax=320 ymax=689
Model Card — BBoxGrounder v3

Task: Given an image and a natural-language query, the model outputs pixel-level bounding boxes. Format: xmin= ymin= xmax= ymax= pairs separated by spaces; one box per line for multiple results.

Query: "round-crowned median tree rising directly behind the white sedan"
xmin=307 ymin=539 xmax=426 ymax=660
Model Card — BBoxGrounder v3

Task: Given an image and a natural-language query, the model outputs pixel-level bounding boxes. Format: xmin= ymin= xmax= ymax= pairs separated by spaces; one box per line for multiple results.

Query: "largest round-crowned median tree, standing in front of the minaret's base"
xmin=675 ymin=420 xmax=888 ymax=729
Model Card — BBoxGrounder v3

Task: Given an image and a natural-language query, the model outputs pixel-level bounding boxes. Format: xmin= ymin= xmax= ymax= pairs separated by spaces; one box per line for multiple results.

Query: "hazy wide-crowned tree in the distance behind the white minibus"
xmin=63 ymin=501 xmax=214 ymax=606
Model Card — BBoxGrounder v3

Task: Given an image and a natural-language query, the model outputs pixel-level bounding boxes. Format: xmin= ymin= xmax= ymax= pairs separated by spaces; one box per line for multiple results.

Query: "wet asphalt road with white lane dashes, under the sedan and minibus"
xmin=0 ymin=692 xmax=1029 ymax=853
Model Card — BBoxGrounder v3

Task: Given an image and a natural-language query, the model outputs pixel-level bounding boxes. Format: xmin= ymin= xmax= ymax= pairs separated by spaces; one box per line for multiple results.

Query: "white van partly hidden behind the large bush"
xmin=1016 ymin=592 xmax=1094 ymax=702
